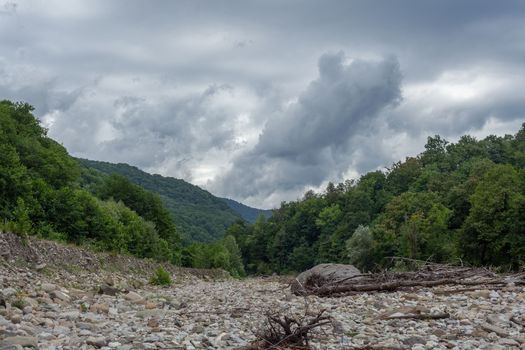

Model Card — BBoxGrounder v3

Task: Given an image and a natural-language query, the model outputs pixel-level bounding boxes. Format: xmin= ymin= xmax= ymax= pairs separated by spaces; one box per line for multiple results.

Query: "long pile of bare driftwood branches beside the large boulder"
xmin=295 ymin=264 xmax=525 ymax=296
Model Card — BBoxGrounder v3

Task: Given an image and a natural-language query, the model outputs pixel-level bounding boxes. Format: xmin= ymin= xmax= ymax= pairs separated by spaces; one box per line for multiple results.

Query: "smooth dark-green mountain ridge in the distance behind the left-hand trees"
xmin=78 ymin=159 xmax=244 ymax=242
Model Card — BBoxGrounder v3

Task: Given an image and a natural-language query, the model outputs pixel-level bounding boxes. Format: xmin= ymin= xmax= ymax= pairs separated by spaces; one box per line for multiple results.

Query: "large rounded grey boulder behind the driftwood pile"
xmin=291 ymin=264 xmax=361 ymax=295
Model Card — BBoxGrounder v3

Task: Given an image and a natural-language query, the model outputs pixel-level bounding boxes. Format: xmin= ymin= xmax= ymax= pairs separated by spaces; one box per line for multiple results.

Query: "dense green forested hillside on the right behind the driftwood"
xmin=228 ymin=124 xmax=525 ymax=273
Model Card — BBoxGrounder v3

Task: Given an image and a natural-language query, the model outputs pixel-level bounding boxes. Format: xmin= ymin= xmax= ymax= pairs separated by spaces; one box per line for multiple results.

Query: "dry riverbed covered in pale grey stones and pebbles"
xmin=0 ymin=235 xmax=525 ymax=350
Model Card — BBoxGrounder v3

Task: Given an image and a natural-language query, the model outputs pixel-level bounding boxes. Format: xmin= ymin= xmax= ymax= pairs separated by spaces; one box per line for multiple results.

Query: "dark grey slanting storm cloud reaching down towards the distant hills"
xmin=211 ymin=52 xmax=401 ymax=204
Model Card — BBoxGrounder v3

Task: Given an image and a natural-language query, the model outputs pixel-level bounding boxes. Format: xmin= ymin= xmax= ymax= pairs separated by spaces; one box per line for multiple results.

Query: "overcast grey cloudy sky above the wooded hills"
xmin=0 ymin=0 xmax=525 ymax=208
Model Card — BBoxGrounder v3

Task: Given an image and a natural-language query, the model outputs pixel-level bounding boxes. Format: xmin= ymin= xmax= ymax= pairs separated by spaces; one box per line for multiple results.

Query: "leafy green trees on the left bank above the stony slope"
xmin=0 ymin=101 xmax=181 ymax=262
